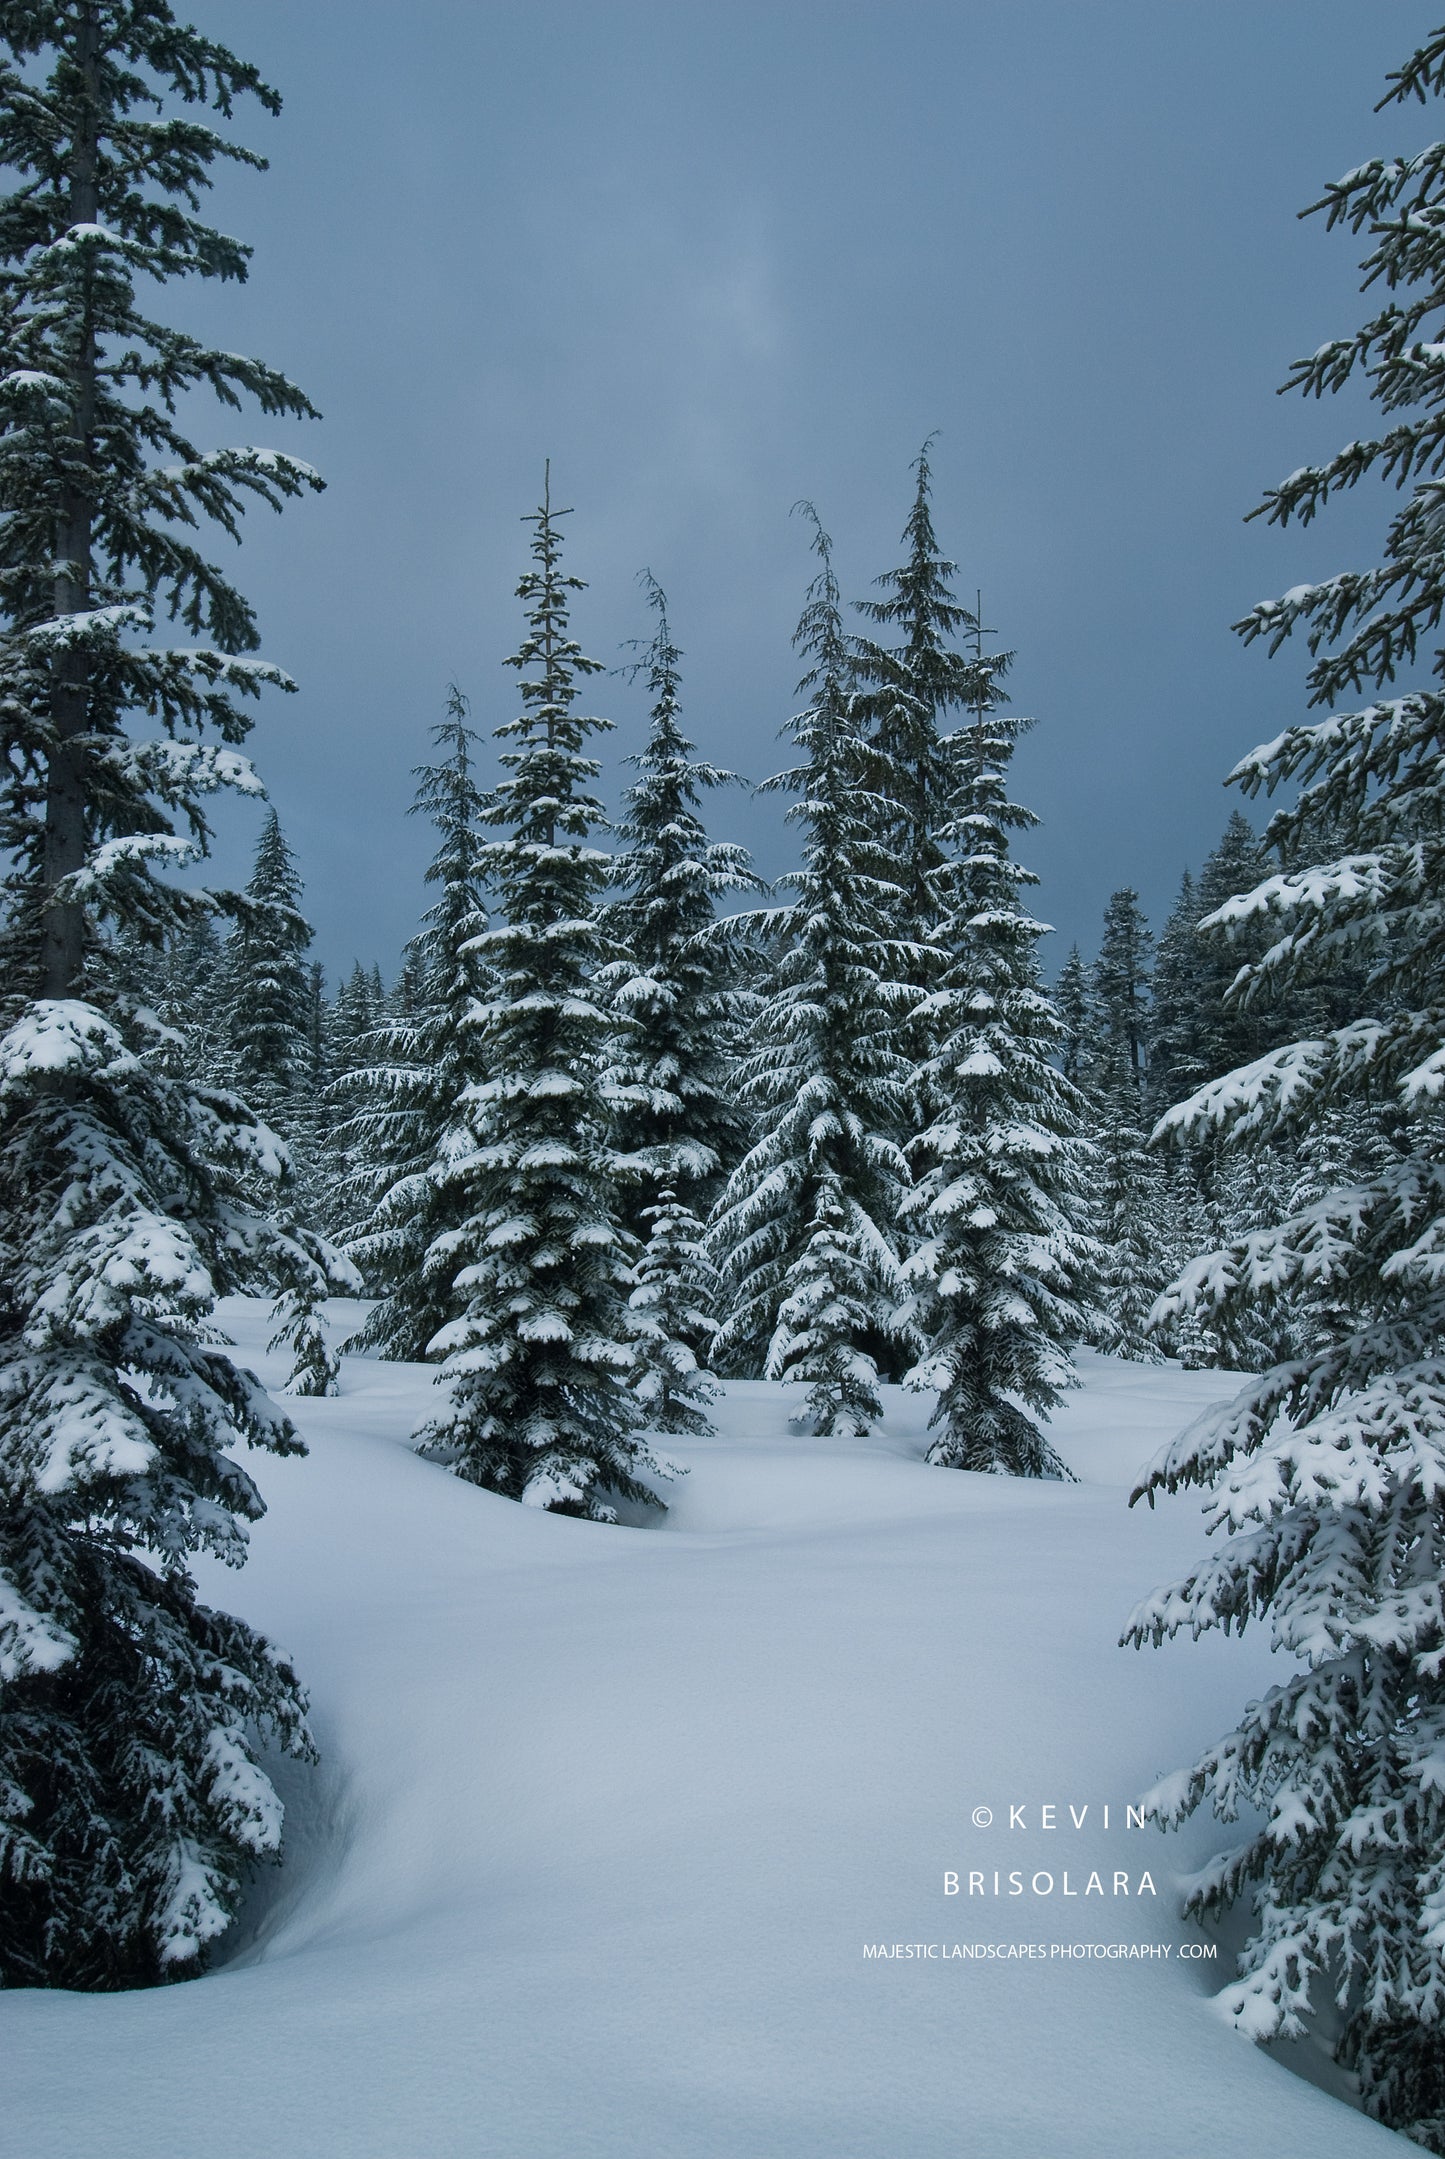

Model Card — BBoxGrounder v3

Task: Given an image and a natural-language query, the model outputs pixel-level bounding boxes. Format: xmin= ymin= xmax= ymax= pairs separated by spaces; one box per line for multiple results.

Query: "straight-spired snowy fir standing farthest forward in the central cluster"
xmin=419 ymin=473 xmax=661 ymax=1522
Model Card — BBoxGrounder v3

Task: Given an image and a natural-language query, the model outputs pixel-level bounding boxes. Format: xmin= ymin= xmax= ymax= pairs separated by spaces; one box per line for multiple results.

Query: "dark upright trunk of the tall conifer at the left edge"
xmin=41 ymin=4 xmax=99 ymax=997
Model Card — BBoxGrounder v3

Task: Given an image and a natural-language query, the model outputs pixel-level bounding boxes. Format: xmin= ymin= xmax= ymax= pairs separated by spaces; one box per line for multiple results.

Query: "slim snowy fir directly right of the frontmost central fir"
xmin=607 ymin=572 xmax=758 ymax=1431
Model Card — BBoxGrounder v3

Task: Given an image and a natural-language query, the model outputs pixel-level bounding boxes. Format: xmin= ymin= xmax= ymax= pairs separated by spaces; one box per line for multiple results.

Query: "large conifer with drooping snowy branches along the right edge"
xmin=1127 ymin=32 xmax=1445 ymax=2153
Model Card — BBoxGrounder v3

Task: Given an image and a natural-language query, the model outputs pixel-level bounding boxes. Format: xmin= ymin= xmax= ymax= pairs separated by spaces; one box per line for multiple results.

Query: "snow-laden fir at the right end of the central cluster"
xmin=903 ymin=661 xmax=1093 ymax=1477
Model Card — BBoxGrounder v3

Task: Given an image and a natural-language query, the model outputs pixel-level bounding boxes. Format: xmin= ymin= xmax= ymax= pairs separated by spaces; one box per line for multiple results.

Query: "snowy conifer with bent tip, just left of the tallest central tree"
xmin=711 ymin=518 xmax=916 ymax=1434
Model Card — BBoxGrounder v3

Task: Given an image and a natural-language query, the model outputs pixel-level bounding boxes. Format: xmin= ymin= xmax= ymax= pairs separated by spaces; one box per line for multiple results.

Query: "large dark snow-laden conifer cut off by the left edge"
xmin=0 ymin=0 xmax=320 ymax=1986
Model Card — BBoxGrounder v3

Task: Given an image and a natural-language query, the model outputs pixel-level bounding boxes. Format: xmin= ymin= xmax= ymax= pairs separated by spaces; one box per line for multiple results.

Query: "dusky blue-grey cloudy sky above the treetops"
xmin=171 ymin=0 xmax=1445 ymax=974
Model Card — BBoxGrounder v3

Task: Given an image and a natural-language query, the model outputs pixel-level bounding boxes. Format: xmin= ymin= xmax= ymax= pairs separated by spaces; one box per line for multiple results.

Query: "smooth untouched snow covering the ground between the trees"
xmin=0 ymin=1300 xmax=1406 ymax=2159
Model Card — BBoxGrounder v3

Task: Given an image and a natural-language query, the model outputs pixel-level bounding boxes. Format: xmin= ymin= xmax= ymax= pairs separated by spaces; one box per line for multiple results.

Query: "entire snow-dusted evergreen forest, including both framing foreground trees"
xmin=0 ymin=0 xmax=1445 ymax=2153
